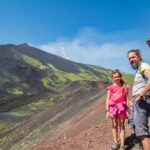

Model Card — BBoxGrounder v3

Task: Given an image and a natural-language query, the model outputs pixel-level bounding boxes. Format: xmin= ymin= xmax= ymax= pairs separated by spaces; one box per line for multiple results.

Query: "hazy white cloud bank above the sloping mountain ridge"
xmin=38 ymin=28 xmax=150 ymax=71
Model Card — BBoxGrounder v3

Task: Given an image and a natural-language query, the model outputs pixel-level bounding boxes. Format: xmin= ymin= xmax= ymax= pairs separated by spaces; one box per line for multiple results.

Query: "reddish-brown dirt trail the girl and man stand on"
xmin=32 ymin=96 xmax=144 ymax=150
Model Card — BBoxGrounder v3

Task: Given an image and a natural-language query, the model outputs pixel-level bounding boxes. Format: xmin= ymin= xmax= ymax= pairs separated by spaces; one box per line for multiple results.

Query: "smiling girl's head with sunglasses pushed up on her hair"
xmin=111 ymin=69 xmax=124 ymax=85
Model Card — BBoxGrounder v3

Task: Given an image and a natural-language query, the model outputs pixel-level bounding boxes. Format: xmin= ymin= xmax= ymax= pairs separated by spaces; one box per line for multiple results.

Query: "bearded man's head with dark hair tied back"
xmin=128 ymin=49 xmax=143 ymax=70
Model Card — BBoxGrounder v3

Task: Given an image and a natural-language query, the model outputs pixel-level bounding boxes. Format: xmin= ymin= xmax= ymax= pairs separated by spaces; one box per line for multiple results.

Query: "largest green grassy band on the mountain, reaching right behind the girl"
xmin=42 ymin=64 xmax=133 ymax=90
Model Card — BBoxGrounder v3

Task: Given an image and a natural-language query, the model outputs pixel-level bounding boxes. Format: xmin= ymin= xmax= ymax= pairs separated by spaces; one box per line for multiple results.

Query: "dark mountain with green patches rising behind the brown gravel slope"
xmin=0 ymin=44 xmax=113 ymax=111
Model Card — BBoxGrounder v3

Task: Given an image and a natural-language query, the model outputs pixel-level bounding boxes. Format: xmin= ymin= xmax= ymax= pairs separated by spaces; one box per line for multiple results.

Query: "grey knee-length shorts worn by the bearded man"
xmin=129 ymin=99 xmax=150 ymax=136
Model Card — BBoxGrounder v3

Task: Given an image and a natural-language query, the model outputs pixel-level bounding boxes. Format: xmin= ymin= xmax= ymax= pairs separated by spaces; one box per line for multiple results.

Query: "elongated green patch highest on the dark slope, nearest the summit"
xmin=22 ymin=55 xmax=48 ymax=69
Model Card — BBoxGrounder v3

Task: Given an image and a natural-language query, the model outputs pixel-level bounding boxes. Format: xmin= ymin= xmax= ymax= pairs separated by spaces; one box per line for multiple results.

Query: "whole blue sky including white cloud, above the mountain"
xmin=0 ymin=0 xmax=150 ymax=72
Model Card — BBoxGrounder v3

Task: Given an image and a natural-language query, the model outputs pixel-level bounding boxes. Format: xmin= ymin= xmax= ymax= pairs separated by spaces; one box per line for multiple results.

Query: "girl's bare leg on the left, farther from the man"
xmin=111 ymin=118 xmax=118 ymax=144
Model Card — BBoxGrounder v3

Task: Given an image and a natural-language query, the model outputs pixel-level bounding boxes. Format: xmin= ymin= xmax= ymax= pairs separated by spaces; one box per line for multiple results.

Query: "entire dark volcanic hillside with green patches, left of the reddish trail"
xmin=0 ymin=44 xmax=133 ymax=150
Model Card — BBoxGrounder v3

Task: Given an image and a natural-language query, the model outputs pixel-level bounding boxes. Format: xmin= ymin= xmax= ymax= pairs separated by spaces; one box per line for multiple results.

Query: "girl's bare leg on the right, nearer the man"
xmin=119 ymin=119 xmax=125 ymax=146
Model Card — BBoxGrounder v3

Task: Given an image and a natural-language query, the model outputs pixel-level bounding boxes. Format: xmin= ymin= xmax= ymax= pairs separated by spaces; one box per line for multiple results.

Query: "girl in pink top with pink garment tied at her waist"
xmin=106 ymin=69 xmax=128 ymax=150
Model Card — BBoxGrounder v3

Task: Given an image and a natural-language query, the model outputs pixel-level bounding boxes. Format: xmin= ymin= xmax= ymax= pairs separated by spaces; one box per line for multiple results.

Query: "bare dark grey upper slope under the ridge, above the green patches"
xmin=6 ymin=44 xmax=79 ymax=73
